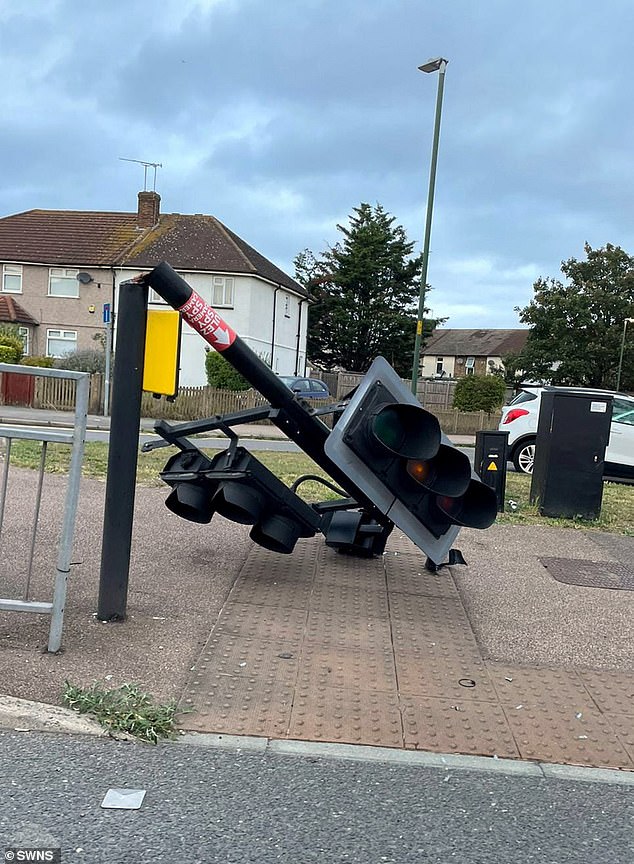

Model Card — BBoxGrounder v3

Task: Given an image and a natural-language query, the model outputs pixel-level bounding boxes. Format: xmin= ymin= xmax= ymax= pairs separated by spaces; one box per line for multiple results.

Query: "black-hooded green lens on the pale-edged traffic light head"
xmin=372 ymin=404 xmax=440 ymax=459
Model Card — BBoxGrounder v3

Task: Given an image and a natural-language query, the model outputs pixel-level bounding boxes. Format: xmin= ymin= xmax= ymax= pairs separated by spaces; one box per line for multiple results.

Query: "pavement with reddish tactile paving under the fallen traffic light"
xmin=0 ymin=412 xmax=634 ymax=770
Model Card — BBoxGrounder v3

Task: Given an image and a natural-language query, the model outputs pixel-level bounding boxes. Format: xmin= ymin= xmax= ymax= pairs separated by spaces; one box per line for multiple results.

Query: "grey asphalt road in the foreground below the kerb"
xmin=0 ymin=732 xmax=634 ymax=864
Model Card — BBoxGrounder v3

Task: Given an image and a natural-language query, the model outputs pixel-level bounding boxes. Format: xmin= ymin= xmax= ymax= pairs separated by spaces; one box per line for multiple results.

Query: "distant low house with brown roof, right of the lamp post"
xmin=421 ymin=328 xmax=528 ymax=378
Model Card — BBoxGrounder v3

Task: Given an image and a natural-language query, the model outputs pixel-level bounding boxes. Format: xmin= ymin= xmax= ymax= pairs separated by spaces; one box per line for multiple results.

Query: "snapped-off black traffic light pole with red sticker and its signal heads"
xmin=138 ymin=262 xmax=497 ymax=569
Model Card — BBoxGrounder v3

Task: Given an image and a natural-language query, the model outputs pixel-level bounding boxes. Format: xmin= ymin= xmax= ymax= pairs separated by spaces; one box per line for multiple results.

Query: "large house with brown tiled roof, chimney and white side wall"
xmin=0 ymin=191 xmax=309 ymax=386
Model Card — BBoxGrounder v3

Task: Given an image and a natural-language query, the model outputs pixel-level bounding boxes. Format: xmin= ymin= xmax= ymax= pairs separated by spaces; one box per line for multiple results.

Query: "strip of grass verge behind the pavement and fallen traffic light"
xmin=6 ymin=440 xmax=634 ymax=535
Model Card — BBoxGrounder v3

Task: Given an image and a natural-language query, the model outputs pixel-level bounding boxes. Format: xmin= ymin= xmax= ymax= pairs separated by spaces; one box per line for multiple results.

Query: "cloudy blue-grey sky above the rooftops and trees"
xmin=0 ymin=0 xmax=634 ymax=327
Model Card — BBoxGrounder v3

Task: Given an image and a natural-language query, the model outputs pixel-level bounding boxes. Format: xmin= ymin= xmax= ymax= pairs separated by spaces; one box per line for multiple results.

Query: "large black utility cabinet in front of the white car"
xmin=530 ymin=387 xmax=612 ymax=519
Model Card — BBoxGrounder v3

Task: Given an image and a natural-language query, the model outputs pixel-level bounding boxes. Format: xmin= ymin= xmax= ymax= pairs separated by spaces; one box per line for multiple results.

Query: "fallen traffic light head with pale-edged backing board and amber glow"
xmin=324 ymin=357 xmax=497 ymax=564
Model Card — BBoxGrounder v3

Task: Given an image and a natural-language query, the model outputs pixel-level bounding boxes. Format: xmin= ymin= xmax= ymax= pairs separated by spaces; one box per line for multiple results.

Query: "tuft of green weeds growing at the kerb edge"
xmin=62 ymin=681 xmax=177 ymax=744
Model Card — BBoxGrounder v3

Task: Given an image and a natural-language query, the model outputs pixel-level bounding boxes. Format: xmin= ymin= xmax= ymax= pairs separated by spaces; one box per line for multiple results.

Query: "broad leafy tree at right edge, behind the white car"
xmin=513 ymin=243 xmax=634 ymax=389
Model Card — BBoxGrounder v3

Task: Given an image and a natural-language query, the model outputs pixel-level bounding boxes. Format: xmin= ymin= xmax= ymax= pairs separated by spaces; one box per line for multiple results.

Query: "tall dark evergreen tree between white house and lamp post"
xmin=295 ymin=203 xmax=440 ymax=377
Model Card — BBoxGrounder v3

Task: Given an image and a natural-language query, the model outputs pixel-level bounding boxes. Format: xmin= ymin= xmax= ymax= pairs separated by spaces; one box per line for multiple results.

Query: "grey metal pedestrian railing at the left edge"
xmin=0 ymin=363 xmax=90 ymax=652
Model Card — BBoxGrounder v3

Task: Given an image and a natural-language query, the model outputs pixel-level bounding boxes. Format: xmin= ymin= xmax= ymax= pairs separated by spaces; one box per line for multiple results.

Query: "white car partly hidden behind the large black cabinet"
xmin=498 ymin=385 xmax=634 ymax=479
